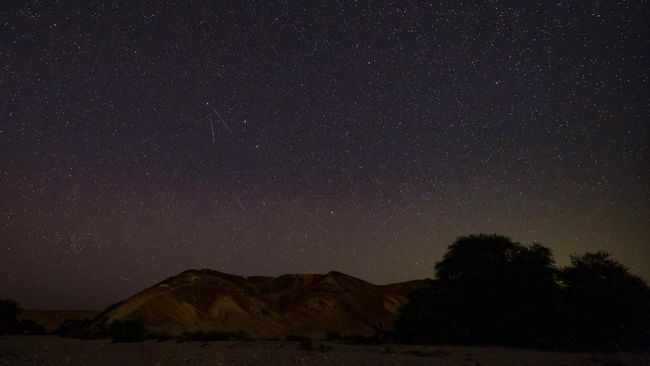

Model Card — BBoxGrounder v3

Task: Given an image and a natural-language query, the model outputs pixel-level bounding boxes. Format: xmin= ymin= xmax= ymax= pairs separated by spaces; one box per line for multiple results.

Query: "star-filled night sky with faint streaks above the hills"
xmin=0 ymin=0 xmax=650 ymax=309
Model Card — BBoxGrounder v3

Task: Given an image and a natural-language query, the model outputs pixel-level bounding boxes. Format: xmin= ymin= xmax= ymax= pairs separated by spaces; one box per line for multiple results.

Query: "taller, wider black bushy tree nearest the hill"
xmin=397 ymin=234 xmax=558 ymax=345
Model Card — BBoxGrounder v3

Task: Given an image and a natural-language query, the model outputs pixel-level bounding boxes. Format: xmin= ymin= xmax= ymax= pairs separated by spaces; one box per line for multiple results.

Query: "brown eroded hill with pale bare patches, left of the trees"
xmin=95 ymin=270 xmax=425 ymax=339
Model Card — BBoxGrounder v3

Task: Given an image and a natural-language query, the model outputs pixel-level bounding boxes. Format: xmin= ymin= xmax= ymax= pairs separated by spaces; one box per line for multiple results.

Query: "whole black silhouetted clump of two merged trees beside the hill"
xmin=396 ymin=234 xmax=650 ymax=350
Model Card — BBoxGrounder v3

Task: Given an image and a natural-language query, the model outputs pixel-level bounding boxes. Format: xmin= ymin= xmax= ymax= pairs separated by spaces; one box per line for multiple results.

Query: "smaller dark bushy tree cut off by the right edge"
xmin=560 ymin=252 xmax=650 ymax=351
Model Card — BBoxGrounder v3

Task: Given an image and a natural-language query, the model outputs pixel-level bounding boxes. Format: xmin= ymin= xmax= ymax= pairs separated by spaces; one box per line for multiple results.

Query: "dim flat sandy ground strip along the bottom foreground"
xmin=0 ymin=336 xmax=650 ymax=366
